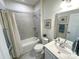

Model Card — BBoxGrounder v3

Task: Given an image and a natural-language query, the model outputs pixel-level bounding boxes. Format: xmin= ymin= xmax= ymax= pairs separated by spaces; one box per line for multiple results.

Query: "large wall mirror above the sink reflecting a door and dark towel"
xmin=55 ymin=9 xmax=79 ymax=42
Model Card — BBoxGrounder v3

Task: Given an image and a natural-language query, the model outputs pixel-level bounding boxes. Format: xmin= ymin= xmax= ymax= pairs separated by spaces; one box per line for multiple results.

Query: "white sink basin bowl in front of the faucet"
xmin=55 ymin=43 xmax=72 ymax=54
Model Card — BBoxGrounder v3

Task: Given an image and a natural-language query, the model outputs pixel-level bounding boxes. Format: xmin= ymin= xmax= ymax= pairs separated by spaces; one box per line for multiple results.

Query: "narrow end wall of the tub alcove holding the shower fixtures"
xmin=33 ymin=2 xmax=41 ymax=38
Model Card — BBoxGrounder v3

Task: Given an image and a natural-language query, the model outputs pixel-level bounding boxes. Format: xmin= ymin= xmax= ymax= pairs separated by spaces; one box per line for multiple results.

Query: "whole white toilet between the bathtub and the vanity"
xmin=34 ymin=37 xmax=48 ymax=59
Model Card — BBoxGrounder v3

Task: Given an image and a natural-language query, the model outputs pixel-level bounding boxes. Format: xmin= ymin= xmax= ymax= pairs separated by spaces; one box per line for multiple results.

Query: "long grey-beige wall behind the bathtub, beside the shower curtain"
xmin=15 ymin=13 xmax=34 ymax=40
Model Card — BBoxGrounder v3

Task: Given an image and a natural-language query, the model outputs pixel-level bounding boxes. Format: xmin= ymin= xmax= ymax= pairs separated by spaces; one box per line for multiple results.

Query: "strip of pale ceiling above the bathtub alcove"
xmin=6 ymin=0 xmax=40 ymax=6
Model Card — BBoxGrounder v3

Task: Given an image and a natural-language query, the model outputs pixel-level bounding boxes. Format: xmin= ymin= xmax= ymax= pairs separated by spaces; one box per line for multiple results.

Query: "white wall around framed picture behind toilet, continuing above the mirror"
xmin=42 ymin=0 xmax=79 ymax=41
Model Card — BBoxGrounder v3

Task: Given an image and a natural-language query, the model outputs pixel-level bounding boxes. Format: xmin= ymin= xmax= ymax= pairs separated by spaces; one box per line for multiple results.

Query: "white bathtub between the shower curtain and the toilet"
xmin=21 ymin=37 xmax=40 ymax=54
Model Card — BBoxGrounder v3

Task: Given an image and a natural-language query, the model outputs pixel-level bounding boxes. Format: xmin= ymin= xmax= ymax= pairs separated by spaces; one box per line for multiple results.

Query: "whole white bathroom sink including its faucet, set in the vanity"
xmin=55 ymin=37 xmax=72 ymax=54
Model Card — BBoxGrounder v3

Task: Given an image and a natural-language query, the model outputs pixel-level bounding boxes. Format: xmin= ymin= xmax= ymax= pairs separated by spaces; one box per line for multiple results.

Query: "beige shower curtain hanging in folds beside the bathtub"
xmin=1 ymin=10 xmax=21 ymax=57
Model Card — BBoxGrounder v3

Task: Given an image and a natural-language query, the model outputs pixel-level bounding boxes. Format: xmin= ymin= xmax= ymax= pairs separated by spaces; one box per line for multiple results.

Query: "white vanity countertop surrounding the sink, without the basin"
xmin=45 ymin=38 xmax=79 ymax=59
